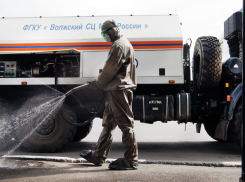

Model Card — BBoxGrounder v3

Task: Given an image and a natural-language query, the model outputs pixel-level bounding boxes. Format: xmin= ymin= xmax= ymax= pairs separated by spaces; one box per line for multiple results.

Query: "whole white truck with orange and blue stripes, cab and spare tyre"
xmin=0 ymin=12 xmax=242 ymax=152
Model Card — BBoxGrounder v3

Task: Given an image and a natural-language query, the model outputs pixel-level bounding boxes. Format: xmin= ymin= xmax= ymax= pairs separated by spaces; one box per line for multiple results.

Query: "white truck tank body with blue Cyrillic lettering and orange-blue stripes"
xmin=0 ymin=15 xmax=184 ymax=85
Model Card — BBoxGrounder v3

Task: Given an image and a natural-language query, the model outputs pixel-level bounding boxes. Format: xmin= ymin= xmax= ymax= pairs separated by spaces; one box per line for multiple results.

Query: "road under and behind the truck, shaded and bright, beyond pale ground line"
xmin=0 ymin=119 xmax=241 ymax=163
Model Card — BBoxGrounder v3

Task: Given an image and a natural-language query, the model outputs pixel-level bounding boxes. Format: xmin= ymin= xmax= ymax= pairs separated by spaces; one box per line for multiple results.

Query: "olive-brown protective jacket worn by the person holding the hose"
xmin=96 ymin=37 xmax=137 ymax=91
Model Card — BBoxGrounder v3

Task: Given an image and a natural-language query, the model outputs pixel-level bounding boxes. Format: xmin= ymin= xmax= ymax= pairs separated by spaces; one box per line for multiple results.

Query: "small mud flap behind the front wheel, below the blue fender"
xmin=214 ymin=120 xmax=230 ymax=141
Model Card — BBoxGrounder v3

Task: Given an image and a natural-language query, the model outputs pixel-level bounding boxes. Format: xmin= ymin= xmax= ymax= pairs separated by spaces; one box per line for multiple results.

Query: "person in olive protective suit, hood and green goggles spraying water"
xmin=80 ymin=20 xmax=138 ymax=170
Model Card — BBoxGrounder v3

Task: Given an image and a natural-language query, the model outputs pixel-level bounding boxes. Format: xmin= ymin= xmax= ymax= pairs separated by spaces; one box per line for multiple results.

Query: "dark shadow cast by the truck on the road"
xmin=1 ymin=141 xmax=241 ymax=162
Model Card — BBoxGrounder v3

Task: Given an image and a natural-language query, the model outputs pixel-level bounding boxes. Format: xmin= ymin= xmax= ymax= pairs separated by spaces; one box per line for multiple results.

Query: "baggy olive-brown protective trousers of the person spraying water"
xmin=94 ymin=89 xmax=138 ymax=164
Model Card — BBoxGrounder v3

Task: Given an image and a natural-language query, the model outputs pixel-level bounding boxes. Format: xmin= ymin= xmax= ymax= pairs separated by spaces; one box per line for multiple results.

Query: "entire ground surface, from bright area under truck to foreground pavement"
xmin=0 ymin=119 xmax=241 ymax=182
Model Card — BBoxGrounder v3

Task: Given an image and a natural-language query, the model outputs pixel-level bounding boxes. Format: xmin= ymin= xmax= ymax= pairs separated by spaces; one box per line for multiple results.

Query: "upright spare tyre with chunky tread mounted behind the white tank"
xmin=192 ymin=36 xmax=222 ymax=93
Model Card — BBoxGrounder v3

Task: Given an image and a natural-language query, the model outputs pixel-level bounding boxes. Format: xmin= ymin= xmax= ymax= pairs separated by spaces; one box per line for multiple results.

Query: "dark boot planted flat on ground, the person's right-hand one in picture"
xmin=109 ymin=158 xmax=138 ymax=170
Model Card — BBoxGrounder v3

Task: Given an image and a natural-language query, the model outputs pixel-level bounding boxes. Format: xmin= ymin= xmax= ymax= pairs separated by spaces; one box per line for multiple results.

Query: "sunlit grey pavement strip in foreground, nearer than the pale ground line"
xmin=0 ymin=161 xmax=240 ymax=182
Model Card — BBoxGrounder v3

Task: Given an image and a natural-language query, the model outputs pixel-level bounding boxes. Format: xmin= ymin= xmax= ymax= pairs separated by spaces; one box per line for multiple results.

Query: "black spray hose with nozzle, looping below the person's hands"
xmin=59 ymin=83 xmax=105 ymax=126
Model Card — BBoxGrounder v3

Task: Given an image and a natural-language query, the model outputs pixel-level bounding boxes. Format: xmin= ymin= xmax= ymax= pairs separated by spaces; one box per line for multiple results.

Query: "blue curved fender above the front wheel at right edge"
xmin=227 ymin=83 xmax=242 ymax=121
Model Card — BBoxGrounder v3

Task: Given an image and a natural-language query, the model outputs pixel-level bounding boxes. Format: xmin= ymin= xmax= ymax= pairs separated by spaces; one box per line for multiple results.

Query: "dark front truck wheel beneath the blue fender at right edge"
xmin=228 ymin=99 xmax=242 ymax=147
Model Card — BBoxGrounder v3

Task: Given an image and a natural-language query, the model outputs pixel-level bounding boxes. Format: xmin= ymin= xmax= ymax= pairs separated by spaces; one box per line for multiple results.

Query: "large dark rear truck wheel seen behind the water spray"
xmin=16 ymin=94 xmax=77 ymax=152
